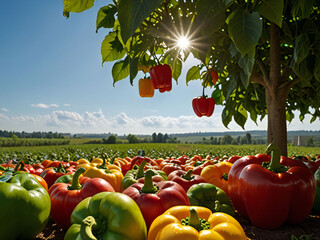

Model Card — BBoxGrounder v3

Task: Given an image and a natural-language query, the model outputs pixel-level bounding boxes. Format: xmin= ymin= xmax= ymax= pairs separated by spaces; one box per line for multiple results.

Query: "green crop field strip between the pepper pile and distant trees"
xmin=0 ymin=143 xmax=320 ymax=163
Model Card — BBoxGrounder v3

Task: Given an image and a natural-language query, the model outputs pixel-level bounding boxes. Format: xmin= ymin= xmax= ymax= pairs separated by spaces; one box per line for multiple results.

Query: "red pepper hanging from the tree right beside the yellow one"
xmin=149 ymin=64 xmax=172 ymax=93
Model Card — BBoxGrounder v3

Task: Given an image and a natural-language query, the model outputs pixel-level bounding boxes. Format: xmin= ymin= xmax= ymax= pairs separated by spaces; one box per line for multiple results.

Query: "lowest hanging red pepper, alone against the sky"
xmin=192 ymin=96 xmax=215 ymax=117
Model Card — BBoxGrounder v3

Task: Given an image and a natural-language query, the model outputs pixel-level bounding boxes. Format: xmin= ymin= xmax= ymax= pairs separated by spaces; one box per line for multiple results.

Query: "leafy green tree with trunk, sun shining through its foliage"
xmin=64 ymin=0 xmax=320 ymax=155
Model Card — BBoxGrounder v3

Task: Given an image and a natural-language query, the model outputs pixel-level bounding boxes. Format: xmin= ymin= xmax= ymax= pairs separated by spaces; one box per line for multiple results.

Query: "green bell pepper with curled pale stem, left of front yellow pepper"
xmin=64 ymin=192 xmax=147 ymax=240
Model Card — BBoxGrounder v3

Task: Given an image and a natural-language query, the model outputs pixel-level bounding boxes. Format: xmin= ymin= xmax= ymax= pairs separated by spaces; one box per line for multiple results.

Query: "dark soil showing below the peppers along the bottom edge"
xmin=36 ymin=214 xmax=320 ymax=240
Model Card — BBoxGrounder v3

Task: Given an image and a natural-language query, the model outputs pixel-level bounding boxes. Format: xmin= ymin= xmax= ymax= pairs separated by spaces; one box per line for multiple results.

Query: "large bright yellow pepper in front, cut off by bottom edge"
xmin=148 ymin=206 xmax=247 ymax=240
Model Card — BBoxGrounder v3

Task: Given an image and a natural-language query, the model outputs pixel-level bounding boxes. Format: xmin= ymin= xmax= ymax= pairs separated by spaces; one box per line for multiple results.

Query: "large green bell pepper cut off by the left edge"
xmin=0 ymin=171 xmax=51 ymax=240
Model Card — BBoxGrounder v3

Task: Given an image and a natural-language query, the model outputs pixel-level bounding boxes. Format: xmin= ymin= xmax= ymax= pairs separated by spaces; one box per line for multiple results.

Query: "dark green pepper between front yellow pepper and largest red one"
xmin=187 ymin=183 xmax=235 ymax=216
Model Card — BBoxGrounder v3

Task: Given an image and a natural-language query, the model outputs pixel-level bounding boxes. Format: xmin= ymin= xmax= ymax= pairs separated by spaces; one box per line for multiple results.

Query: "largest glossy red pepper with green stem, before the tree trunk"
xmin=228 ymin=144 xmax=315 ymax=229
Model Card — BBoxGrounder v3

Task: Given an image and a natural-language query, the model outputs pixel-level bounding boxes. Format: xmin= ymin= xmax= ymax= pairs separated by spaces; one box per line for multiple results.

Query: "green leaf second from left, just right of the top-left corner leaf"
xmin=96 ymin=4 xmax=117 ymax=32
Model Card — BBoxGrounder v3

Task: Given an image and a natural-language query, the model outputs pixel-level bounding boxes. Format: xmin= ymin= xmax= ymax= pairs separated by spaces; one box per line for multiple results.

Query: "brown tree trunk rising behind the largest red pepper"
xmin=265 ymin=23 xmax=289 ymax=156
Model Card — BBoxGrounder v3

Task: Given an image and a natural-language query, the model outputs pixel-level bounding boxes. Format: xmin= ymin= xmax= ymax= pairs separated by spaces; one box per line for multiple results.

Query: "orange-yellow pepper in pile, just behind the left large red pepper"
xmin=83 ymin=159 xmax=123 ymax=192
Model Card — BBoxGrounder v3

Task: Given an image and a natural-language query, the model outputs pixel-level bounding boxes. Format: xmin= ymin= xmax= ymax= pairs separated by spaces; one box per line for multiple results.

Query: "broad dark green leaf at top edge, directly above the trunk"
xmin=257 ymin=0 xmax=284 ymax=28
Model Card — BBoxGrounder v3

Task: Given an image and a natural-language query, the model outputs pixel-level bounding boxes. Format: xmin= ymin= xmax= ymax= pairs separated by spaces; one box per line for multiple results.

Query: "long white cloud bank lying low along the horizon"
xmin=0 ymin=109 xmax=319 ymax=134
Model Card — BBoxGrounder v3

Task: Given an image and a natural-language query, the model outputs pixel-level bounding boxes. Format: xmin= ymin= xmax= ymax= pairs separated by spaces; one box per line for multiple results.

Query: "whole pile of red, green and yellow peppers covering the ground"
xmin=0 ymin=144 xmax=320 ymax=240
